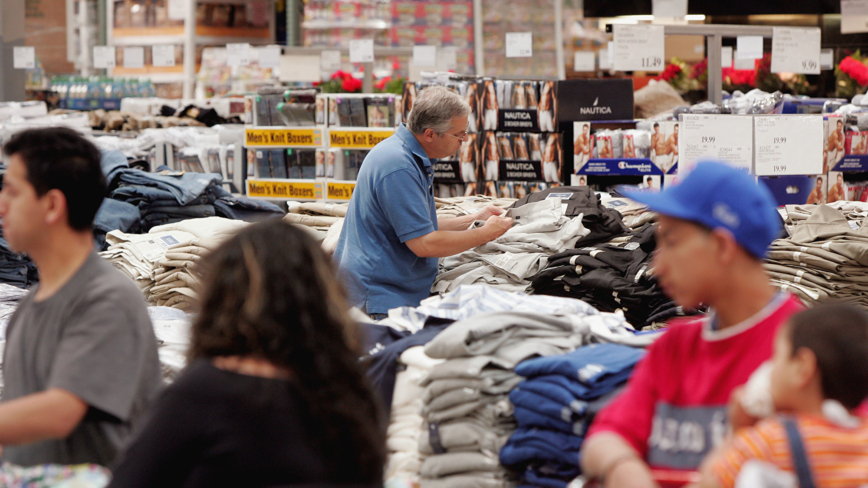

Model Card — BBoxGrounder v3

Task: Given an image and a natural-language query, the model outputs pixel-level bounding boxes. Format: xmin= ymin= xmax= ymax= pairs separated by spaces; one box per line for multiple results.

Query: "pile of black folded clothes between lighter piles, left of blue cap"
xmin=528 ymin=223 xmax=697 ymax=328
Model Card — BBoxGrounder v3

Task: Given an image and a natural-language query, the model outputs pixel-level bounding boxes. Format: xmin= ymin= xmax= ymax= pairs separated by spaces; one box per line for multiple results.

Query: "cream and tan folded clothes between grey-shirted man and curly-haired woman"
xmin=100 ymin=217 xmax=247 ymax=310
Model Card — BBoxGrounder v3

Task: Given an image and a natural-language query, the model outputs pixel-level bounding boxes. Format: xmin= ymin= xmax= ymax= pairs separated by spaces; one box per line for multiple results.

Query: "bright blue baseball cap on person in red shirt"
xmin=621 ymin=162 xmax=782 ymax=259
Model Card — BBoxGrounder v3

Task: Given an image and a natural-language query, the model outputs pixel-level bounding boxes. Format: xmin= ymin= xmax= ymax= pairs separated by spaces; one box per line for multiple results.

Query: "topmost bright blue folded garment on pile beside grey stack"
xmin=515 ymin=344 xmax=645 ymax=387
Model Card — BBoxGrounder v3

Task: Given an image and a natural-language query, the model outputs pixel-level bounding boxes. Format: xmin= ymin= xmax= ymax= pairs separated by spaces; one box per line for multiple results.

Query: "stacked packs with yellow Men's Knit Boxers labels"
xmin=245 ymin=88 xmax=400 ymax=203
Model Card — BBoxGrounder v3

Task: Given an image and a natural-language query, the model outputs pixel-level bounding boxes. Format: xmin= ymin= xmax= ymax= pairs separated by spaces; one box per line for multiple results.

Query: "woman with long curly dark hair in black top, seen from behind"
xmin=111 ymin=221 xmax=386 ymax=487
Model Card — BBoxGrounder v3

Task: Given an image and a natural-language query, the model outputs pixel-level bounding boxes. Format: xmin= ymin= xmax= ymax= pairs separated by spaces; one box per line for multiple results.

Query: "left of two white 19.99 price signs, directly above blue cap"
xmin=678 ymin=114 xmax=753 ymax=178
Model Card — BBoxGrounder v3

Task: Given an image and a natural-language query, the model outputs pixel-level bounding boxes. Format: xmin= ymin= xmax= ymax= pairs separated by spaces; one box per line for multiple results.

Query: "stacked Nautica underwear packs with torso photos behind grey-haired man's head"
xmin=403 ymin=75 xmax=563 ymax=198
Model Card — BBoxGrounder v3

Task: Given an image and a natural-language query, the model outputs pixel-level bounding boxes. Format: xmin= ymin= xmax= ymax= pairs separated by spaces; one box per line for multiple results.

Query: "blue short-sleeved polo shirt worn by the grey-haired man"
xmin=335 ymin=125 xmax=437 ymax=313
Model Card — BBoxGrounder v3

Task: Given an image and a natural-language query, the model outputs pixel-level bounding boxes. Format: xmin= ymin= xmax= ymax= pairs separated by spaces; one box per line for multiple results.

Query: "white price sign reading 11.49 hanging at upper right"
xmin=614 ymin=24 xmax=666 ymax=71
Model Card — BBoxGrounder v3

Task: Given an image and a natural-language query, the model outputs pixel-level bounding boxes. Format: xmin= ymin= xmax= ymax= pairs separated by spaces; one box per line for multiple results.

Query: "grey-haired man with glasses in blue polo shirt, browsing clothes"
xmin=335 ymin=86 xmax=512 ymax=319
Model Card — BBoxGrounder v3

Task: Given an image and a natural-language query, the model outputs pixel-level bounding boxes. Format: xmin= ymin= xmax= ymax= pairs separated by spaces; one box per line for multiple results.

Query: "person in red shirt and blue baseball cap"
xmin=581 ymin=162 xmax=802 ymax=488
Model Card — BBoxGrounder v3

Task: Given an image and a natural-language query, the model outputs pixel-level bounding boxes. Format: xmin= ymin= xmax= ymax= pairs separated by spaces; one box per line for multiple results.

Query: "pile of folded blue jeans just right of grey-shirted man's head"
xmin=102 ymin=151 xmax=284 ymax=237
